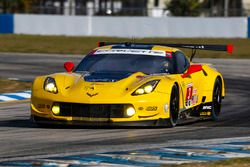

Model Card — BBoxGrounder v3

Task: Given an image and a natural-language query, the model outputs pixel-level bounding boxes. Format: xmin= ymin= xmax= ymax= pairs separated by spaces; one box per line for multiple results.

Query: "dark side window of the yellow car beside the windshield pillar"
xmin=175 ymin=51 xmax=190 ymax=74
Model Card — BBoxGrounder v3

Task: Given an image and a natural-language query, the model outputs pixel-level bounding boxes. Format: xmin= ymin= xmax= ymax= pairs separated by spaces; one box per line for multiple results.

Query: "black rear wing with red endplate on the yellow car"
xmin=98 ymin=42 xmax=234 ymax=61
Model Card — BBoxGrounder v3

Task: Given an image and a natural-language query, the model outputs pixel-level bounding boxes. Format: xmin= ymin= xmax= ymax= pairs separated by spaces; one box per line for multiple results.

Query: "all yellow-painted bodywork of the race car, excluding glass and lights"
xmin=31 ymin=46 xmax=225 ymax=122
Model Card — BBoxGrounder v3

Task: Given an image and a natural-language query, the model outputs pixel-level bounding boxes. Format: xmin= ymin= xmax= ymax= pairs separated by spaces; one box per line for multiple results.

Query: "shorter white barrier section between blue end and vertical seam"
xmin=14 ymin=14 xmax=88 ymax=36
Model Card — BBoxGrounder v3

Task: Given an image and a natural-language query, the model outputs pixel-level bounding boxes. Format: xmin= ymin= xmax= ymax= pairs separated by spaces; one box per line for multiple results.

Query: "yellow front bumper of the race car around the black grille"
xmin=31 ymin=90 xmax=169 ymax=125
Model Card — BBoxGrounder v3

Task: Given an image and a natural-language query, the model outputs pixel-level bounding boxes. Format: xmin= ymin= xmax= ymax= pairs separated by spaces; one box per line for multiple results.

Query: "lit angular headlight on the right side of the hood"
xmin=132 ymin=80 xmax=160 ymax=96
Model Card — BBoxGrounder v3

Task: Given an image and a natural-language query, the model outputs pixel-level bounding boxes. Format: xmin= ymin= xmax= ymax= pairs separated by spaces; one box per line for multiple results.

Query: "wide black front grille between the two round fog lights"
xmin=59 ymin=103 xmax=126 ymax=118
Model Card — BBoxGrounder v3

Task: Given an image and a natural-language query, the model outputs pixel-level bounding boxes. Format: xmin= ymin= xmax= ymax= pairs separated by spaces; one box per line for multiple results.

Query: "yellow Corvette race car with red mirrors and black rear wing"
xmin=31 ymin=42 xmax=233 ymax=127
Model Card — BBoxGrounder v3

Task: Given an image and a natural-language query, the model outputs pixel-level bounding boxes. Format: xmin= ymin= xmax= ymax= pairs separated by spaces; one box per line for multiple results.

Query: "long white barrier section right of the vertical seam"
xmin=91 ymin=17 xmax=247 ymax=38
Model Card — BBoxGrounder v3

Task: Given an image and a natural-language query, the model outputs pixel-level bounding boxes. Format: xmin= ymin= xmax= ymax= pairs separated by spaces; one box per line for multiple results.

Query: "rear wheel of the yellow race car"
xmin=211 ymin=78 xmax=222 ymax=120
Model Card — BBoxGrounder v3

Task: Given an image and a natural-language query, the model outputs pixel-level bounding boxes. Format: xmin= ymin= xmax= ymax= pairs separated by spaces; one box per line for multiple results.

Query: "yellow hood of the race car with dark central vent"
xmin=33 ymin=72 xmax=170 ymax=102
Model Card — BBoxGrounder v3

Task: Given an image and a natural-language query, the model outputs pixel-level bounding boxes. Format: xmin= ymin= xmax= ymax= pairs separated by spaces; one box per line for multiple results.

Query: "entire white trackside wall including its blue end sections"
xmin=0 ymin=14 xmax=250 ymax=38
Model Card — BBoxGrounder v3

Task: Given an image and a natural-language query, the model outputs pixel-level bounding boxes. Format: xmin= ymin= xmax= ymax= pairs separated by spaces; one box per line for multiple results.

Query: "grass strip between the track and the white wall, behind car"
xmin=0 ymin=35 xmax=250 ymax=58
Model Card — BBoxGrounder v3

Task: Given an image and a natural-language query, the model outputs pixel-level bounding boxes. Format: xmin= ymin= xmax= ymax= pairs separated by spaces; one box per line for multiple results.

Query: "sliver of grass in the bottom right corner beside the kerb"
xmin=161 ymin=158 xmax=250 ymax=167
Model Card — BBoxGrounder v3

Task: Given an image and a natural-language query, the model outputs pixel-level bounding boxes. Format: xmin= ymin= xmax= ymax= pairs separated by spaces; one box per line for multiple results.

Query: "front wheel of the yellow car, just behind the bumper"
xmin=166 ymin=85 xmax=179 ymax=127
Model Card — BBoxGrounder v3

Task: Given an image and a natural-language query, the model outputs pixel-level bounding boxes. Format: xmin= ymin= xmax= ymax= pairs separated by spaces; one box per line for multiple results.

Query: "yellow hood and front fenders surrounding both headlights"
xmin=32 ymin=72 xmax=176 ymax=104
